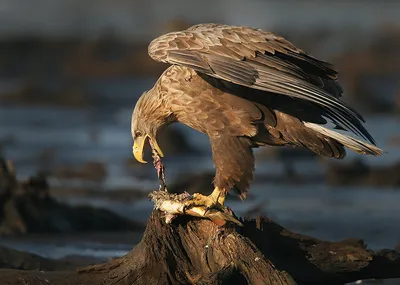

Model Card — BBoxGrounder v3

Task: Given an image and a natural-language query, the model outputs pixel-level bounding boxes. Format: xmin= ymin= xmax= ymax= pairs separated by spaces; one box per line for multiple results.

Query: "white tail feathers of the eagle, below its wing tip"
xmin=304 ymin=122 xmax=384 ymax=155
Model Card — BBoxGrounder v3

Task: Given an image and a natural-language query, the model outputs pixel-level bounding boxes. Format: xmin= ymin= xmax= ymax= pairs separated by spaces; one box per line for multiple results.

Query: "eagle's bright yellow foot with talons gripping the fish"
xmin=185 ymin=187 xmax=226 ymax=213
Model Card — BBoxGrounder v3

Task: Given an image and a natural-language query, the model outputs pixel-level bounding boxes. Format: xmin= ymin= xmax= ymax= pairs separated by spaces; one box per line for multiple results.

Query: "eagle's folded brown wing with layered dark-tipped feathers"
xmin=149 ymin=24 xmax=375 ymax=144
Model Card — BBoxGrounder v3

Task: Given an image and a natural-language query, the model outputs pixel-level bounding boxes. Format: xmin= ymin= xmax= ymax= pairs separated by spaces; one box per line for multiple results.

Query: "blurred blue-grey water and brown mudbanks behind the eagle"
xmin=0 ymin=0 xmax=400 ymax=272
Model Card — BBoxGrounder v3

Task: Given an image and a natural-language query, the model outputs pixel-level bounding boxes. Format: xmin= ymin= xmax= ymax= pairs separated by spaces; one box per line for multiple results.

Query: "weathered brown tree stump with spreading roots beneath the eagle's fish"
xmin=0 ymin=211 xmax=400 ymax=285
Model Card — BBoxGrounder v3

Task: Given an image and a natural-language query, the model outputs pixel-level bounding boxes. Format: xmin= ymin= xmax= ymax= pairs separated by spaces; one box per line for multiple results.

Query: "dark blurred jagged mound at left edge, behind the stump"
xmin=0 ymin=159 xmax=144 ymax=236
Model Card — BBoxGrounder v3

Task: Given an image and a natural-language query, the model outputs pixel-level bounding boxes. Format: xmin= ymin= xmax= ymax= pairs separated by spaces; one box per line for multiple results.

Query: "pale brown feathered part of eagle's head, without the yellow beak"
xmin=131 ymin=88 xmax=174 ymax=137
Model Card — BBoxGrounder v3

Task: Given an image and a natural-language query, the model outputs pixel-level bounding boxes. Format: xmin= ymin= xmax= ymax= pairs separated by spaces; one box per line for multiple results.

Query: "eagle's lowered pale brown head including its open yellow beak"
xmin=131 ymin=89 xmax=173 ymax=163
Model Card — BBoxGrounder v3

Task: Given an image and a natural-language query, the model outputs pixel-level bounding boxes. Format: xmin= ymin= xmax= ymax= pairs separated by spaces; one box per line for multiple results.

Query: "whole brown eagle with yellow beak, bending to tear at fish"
xmin=131 ymin=23 xmax=383 ymax=215
